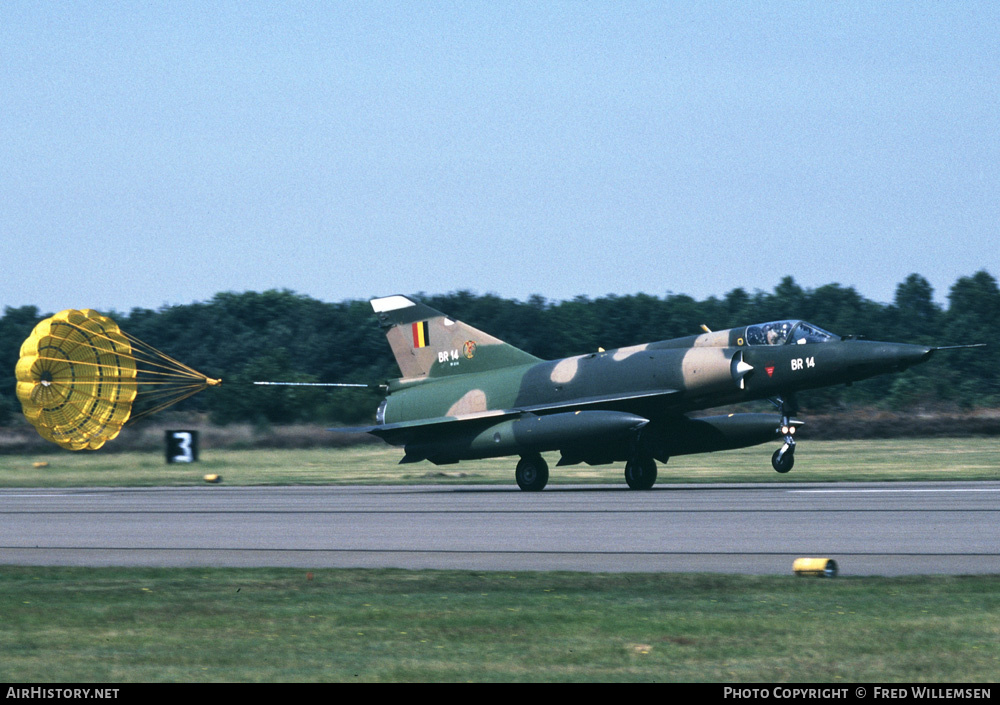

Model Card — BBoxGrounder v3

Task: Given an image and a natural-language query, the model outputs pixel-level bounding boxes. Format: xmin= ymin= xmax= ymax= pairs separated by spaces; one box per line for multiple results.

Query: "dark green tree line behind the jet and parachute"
xmin=0 ymin=270 xmax=1000 ymax=425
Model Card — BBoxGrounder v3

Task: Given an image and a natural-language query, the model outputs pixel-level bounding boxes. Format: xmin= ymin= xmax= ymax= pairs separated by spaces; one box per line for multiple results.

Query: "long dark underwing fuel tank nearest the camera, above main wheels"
xmin=400 ymin=411 xmax=649 ymax=464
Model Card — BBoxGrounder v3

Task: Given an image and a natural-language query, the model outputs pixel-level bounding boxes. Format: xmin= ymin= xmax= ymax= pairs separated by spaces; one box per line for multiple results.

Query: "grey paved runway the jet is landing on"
xmin=0 ymin=482 xmax=1000 ymax=575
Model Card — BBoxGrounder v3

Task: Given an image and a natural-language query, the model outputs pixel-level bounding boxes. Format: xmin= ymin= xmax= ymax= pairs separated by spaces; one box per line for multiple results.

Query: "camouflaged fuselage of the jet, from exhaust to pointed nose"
xmin=380 ymin=327 xmax=932 ymax=424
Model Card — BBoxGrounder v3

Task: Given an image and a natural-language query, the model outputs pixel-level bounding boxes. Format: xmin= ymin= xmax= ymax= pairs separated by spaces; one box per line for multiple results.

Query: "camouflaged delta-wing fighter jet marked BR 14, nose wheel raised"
xmin=331 ymin=295 xmax=966 ymax=491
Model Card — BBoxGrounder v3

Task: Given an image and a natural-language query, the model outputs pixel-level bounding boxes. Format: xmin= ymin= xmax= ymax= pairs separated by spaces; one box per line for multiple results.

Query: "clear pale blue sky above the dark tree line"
xmin=0 ymin=0 xmax=1000 ymax=315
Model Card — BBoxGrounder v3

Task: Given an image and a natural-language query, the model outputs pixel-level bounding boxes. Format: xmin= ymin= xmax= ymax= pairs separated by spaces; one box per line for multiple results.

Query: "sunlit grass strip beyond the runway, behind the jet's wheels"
xmin=0 ymin=437 xmax=1000 ymax=487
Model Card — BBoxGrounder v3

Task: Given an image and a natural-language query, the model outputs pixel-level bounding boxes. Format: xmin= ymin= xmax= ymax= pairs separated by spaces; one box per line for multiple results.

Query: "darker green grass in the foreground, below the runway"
xmin=0 ymin=567 xmax=1000 ymax=683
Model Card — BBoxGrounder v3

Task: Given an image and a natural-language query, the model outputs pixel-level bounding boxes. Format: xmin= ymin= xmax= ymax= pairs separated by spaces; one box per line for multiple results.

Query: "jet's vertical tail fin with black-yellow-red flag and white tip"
xmin=371 ymin=295 xmax=541 ymax=379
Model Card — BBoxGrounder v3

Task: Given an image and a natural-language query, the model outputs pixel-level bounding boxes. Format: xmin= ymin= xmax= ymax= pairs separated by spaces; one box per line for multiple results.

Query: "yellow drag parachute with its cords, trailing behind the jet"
xmin=16 ymin=309 xmax=220 ymax=450
